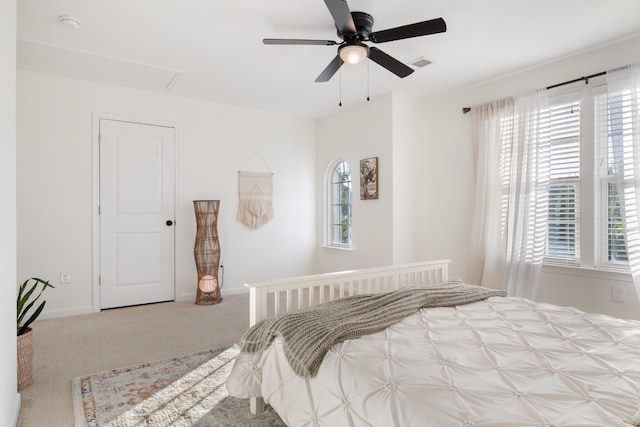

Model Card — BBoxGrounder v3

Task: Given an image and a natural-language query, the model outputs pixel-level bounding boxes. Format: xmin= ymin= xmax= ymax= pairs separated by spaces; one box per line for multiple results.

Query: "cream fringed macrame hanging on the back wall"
xmin=238 ymin=153 xmax=273 ymax=229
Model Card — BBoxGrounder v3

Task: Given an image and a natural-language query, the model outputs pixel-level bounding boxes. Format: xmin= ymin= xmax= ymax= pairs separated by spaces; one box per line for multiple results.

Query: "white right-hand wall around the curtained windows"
xmin=420 ymin=37 xmax=640 ymax=319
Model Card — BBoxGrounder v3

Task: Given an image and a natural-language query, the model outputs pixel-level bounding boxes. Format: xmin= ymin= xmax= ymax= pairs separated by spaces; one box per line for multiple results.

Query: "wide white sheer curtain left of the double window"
xmin=469 ymin=90 xmax=550 ymax=299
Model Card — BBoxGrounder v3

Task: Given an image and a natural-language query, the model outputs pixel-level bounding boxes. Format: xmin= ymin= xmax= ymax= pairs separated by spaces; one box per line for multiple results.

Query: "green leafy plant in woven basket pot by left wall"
xmin=17 ymin=277 xmax=55 ymax=391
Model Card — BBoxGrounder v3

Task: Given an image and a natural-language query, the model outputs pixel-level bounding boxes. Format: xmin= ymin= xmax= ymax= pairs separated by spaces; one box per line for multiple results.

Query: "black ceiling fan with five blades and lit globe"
xmin=262 ymin=0 xmax=447 ymax=82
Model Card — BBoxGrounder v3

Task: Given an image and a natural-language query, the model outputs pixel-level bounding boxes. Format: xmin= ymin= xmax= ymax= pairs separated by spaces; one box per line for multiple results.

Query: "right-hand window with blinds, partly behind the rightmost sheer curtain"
xmin=594 ymin=93 xmax=633 ymax=265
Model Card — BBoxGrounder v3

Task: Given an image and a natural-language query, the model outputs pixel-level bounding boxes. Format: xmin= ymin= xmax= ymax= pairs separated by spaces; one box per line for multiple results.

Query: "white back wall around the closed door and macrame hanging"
xmin=18 ymin=69 xmax=316 ymax=318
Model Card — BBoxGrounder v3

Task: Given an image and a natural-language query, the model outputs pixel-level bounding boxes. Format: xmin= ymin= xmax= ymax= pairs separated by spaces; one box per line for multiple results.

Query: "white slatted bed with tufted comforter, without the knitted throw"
xmin=226 ymin=260 xmax=640 ymax=427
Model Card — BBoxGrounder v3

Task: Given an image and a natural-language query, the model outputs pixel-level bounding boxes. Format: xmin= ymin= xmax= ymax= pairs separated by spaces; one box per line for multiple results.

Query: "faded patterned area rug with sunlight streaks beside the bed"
xmin=73 ymin=345 xmax=285 ymax=427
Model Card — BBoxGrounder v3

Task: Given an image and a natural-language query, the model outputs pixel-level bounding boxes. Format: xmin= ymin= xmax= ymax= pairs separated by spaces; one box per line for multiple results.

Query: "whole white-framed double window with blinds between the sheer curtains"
xmin=488 ymin=78 xmax=640 ymax=271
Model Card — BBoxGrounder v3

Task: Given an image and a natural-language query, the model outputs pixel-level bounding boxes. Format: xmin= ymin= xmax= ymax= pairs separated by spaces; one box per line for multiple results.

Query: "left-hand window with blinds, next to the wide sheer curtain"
xmin=545 ymin=101 xmax=580 ymax=264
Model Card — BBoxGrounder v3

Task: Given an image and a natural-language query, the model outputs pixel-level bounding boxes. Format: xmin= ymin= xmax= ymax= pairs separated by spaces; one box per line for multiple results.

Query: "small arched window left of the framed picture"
xmin=327 ymin=160 xmax=351 ymax=247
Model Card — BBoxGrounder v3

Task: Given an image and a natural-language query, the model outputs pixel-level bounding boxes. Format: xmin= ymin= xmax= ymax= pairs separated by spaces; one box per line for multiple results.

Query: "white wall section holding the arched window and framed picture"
xmin=317 ymin=93 xmax=426 ymax=272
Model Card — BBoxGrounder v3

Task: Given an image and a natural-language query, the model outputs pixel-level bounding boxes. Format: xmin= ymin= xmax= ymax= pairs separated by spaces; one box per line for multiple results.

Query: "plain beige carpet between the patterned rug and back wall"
xmin=18 ymin=294 xmax=254 ymax=427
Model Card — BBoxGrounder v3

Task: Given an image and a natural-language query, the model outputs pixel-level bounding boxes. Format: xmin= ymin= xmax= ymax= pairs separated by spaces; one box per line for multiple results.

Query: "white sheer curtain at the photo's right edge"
xmin=607 ymin=64 xmax=640 ymax=295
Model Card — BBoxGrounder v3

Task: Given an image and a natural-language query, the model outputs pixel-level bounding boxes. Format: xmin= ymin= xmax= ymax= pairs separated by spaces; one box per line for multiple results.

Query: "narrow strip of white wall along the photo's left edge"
xmin=0 ymin=0 xmax=20 ymax=426
